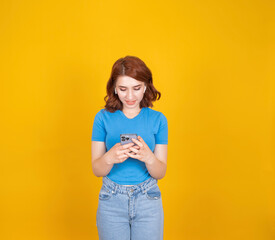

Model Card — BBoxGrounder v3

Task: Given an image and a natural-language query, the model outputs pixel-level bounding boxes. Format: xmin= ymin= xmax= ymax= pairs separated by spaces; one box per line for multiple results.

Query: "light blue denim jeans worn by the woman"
xmin=96 ymin=176 xmax=164 ymax=240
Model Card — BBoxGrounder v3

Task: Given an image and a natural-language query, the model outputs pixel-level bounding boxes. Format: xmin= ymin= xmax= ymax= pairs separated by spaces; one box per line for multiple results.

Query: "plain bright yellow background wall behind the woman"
xmin=0 ymin=0 xmax=275 ymax=240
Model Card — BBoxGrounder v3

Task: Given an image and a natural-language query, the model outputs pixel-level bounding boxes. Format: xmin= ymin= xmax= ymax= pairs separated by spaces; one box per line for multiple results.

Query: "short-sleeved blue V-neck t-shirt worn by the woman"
xmin=92 ymin=107 xmax=168 ymax=185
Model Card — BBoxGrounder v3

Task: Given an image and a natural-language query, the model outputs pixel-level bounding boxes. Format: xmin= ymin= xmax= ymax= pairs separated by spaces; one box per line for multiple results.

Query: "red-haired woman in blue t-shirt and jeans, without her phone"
xmin=92 ymin=56 xmax=168 ymax=240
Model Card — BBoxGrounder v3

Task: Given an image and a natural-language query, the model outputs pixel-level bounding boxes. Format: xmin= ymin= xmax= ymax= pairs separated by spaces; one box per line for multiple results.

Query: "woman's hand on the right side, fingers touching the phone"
xmin=125 ymin=136 xmax=154 ymax=163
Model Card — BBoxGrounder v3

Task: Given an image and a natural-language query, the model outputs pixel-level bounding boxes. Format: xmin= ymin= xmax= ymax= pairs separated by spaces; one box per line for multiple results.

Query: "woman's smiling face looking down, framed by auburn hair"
xmin=116 ymin=76 xmax=148 ymax=109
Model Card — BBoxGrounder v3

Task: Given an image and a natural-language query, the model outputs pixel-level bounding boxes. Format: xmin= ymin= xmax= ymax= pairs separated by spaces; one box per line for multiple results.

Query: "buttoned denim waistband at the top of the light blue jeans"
xmin=102 ymin=176 xmax=158 ymax=194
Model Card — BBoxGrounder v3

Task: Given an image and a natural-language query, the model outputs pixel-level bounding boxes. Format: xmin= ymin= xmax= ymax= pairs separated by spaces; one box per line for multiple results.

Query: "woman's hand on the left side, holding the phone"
xmin=106 ymin=143 xmax=134 ymax=164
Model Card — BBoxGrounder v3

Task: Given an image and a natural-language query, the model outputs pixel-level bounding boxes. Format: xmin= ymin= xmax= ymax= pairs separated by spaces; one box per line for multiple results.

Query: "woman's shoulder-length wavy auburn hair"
xmin=104 ymin=56 xmax=161 ymax=112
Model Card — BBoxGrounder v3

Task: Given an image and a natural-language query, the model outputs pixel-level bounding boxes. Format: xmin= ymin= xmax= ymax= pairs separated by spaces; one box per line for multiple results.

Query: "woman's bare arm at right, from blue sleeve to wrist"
xmin=145 ymin=144 xmax=168 ymax=179
